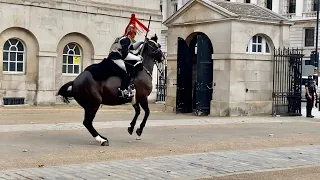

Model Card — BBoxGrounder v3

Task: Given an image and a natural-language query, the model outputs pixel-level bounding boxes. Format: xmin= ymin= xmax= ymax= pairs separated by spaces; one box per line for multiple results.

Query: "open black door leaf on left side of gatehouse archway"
xmin=176 ymin=37 xmax=192 ymax=113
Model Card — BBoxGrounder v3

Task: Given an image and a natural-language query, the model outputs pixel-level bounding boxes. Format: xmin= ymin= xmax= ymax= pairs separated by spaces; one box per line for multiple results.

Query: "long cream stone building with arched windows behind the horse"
xmin=0 ymin=0 xmax=162 ymax=105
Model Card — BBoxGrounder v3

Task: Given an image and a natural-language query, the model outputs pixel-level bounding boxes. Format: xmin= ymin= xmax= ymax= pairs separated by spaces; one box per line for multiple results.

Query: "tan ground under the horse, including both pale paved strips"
xmin=0 ymin=106 xmax=320 ymax=180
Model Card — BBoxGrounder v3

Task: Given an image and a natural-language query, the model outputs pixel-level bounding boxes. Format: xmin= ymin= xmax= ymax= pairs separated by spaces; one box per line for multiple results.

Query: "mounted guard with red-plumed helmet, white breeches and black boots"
xmin=108 ymin=14 xmax=149 ymax=98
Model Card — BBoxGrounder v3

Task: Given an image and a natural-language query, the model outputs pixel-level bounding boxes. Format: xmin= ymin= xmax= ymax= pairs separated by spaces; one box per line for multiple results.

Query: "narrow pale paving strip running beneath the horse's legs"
xmin=0 ymin=117 xmax=308 ymax=133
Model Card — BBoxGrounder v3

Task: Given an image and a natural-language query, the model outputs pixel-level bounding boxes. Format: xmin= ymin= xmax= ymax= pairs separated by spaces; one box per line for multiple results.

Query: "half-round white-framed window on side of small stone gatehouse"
xmin=246 ymin=35 xmax=270 ymax=54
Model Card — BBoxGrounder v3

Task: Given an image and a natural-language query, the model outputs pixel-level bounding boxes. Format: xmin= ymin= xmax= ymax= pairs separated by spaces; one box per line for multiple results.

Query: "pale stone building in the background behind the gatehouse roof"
xmin=160 ymin=0 xmax=320 ymax=76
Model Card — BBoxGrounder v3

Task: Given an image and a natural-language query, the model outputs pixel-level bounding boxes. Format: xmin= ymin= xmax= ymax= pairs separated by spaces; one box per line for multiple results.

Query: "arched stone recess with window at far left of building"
xmin=0 ymin=27 xmax=39 ymax=105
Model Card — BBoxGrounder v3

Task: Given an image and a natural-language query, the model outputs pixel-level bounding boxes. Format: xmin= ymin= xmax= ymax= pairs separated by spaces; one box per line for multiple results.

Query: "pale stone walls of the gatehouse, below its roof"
xmin=166 ymin=21 xmax=289 ymax=116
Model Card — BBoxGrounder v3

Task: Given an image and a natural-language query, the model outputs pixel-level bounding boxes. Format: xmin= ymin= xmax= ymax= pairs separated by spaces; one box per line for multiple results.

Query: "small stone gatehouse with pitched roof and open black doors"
xmin=164 ymin=0 xmax=292 ymax=116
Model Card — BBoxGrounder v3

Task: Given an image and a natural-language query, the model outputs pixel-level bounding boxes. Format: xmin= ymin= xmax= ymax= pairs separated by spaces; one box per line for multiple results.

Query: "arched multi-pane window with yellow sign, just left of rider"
xmin=62 ymin=43 xmax=82 ymax=74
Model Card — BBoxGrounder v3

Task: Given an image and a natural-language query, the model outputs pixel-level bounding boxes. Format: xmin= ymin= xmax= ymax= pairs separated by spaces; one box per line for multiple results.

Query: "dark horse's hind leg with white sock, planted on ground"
xmin=83 ymin=106 xmax=109 ymax=146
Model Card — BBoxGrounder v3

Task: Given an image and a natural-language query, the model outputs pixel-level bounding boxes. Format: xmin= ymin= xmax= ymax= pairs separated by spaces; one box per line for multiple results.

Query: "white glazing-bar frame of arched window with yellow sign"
xmin=61 ymin=42 xmax=82 ymax=76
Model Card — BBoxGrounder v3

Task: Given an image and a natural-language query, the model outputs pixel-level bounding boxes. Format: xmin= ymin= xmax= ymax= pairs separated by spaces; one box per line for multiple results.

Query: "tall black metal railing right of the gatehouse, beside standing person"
xmin=272 ymin=48 xmax=304 ymax=116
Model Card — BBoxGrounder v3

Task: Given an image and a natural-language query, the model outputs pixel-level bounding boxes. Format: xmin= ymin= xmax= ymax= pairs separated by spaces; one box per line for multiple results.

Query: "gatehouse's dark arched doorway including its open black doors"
xmin=176 ymin=32 xmax=213 ymax=116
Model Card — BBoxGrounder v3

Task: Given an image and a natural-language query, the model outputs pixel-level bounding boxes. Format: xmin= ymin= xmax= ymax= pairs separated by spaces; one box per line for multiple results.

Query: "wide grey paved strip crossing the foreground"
xmin=0 ymin=146 xmax=320 ymax=180
